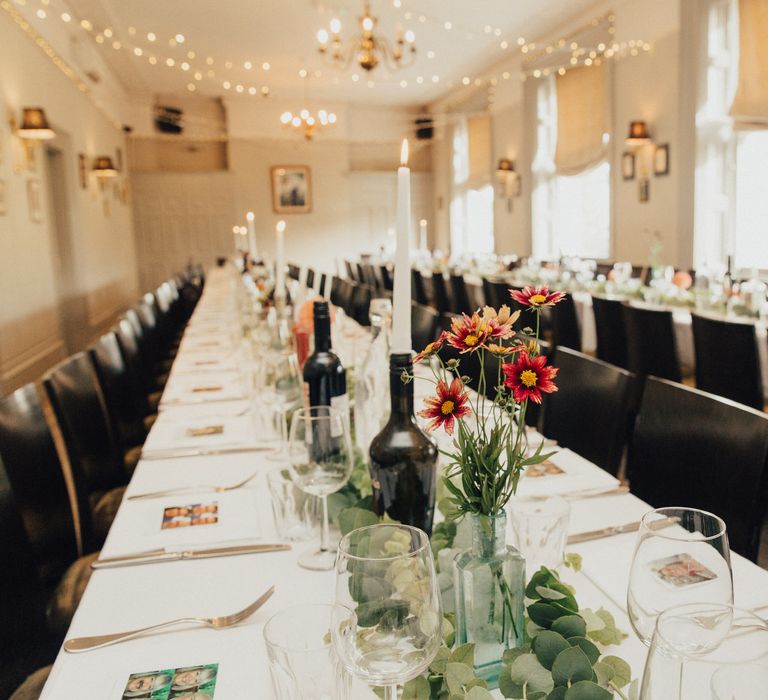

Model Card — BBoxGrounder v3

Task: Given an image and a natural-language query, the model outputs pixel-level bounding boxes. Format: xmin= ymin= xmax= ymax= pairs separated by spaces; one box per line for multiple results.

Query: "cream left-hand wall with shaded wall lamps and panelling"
xmin=0 ymin=6 xmax=138 ymax=392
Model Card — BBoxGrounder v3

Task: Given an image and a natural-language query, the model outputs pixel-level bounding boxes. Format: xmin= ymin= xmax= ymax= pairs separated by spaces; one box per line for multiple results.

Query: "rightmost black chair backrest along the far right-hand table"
xmin=691 ymin=314 xmax=765 ymax=410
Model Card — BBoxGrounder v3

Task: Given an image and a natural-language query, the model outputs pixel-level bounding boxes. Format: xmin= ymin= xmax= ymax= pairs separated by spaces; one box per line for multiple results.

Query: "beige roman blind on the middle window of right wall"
xmin=555 ymin=64 xmax=608 ymax=175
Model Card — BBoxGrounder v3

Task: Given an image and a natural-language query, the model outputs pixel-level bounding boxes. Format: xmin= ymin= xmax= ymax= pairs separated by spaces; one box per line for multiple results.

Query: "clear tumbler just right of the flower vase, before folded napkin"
xmin=509 ymin=496 xmax=571 ymax=572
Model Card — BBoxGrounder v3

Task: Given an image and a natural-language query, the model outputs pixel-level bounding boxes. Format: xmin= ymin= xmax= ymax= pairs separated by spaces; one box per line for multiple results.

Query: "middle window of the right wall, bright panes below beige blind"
xmin=532 ymin=78 xmax=611 ymax=260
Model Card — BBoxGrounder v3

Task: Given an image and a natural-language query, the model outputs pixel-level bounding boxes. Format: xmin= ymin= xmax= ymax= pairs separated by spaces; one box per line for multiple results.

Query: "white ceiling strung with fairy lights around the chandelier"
xmin=63 ymin=0 xmax=594 ymax=106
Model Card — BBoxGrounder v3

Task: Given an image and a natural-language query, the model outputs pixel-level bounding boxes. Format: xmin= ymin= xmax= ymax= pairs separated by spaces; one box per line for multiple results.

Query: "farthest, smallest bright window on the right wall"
xmin=451 ymin=117 xmax=494 ymax=257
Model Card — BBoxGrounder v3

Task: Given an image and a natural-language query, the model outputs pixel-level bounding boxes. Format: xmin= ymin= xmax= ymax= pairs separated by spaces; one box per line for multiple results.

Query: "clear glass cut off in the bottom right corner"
xmin=640 ymin=602 xmax=768 ymax=700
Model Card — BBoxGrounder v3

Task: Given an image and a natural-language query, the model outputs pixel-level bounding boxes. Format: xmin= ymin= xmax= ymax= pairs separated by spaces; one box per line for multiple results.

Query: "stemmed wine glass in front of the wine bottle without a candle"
xmin=288 ymin=406 xmax=352 ymax=571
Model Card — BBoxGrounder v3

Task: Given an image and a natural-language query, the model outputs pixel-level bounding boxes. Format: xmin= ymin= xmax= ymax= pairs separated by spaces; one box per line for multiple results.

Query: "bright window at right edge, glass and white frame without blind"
xmin=694 ymin=0 xmax=768 ymax=271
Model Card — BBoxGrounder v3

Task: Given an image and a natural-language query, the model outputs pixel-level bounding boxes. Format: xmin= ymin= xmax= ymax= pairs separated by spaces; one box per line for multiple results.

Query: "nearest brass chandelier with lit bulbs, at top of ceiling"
xmin=317 ymin=0 xmax=416 ymax=71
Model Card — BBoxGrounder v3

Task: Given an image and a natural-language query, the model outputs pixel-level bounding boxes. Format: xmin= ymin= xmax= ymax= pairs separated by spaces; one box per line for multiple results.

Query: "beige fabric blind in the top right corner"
xmin=731 ymin=0 xmax=768 ymax=128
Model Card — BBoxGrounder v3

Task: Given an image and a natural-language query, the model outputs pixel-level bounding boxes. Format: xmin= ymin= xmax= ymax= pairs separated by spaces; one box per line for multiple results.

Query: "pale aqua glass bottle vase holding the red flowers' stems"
xmin=453 ymin=512 xmax=525 ymax=688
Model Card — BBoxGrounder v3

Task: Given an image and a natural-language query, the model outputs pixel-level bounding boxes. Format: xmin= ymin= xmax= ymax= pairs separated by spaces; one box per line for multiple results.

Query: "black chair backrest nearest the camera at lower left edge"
xmin=0 ymin=454 xmax=52 ymax=698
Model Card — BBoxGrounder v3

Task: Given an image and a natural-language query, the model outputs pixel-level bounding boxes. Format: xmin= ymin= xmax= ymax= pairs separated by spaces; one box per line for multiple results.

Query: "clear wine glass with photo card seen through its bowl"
xmin=627 ymin=508 xmax=733 ymax=644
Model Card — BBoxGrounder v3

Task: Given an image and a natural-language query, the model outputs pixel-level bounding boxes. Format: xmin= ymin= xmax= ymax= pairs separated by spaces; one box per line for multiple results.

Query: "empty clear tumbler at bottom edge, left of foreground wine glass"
xmin=264 ymin=605 xmax=351 ymax=700
